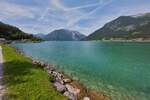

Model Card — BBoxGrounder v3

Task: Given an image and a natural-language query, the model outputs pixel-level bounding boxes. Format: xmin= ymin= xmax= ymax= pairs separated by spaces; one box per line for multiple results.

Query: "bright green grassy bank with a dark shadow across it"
xmin=2 ymin=45 xmax=67 ymax=100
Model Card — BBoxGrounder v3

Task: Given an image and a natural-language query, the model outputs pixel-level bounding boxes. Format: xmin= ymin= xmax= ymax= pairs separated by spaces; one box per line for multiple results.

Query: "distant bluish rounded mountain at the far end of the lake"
xmin=45 ymin=29 xmax=85 ymax=41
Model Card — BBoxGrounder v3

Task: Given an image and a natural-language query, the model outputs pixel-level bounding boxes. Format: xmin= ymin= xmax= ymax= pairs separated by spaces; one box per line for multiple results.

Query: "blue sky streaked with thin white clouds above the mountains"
xmin=0 ymin=0 xmax=150 ymax=35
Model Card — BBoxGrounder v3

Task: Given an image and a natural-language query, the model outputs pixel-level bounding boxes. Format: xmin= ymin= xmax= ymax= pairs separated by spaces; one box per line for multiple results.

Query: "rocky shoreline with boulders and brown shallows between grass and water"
xmin=11 ymin=46 xmax=110 ymax=100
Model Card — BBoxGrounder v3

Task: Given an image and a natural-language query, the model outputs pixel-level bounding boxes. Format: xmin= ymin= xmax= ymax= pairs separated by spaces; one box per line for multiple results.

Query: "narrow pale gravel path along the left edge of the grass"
xmin=0 ymin=46 xmax=4 ymax=100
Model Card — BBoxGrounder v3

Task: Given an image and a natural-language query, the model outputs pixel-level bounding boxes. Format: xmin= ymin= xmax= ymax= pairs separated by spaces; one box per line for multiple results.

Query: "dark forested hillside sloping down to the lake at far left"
xmin=0 ymin=22 xmax=40 ymax=41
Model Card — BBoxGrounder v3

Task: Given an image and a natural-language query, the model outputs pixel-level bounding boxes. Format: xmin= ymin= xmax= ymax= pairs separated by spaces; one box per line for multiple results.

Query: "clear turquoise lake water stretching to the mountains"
xmin=15 ymin=41 xmax=150 ymax=100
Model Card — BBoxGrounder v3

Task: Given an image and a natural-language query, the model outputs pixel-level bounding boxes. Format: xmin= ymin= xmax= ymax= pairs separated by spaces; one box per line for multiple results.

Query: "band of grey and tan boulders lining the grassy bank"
xmin=33 ymin=60 xmax=90 ymax=100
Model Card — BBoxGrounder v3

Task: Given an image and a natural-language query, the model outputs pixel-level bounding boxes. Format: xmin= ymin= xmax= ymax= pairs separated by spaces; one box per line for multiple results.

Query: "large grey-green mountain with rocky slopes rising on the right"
xmin=86 ymin=13 xmax=150 ymax=40
